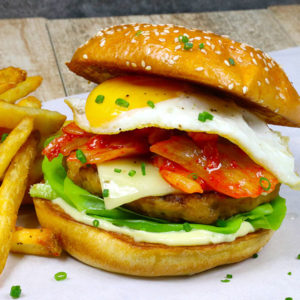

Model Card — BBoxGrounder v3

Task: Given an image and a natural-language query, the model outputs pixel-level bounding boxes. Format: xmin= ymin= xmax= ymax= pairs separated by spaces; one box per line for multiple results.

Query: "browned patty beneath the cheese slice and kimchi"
xmin=67 ymin=162 xmax=280 ymax=224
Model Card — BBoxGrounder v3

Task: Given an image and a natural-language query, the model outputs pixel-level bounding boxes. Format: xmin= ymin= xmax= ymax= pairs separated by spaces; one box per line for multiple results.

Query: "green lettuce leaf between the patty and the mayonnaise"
xmin=30 ymin=154 xmax=286 ymax=234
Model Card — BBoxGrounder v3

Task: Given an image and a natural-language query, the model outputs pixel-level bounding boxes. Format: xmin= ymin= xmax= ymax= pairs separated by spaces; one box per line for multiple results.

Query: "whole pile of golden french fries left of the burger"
xmin=0 ymin=67 xmax=65 ymax=274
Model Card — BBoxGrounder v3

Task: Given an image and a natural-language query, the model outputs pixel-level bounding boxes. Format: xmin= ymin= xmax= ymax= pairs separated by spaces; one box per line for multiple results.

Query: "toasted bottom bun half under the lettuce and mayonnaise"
xmin=34 ymin=199 xmax=273 ymax=277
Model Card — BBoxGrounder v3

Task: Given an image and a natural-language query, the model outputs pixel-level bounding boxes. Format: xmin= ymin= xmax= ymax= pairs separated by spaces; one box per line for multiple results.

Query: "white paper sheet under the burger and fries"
xmin=0 ymin=48 xmax=300 ymax=300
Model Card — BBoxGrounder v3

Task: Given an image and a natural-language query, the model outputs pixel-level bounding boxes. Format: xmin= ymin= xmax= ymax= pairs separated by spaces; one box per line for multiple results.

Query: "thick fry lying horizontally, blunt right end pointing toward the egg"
xmin=0 ymin=100 xmax=66 ymax=136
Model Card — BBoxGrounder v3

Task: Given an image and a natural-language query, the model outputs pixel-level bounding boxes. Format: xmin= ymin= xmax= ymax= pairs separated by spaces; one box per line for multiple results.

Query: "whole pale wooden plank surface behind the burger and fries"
xmin=0 ymin=5 xmax=300 ymax=101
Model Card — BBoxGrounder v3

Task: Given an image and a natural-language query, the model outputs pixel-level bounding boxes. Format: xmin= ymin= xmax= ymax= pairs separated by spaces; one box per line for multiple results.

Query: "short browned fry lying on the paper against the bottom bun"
xmin=10 ymin=227 xmax=62 ymax=256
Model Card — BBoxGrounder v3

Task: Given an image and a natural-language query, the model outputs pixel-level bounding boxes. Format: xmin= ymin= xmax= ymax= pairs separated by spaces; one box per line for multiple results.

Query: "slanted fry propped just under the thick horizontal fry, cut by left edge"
xmin=0 ymin=117 xmax=33 ymax=178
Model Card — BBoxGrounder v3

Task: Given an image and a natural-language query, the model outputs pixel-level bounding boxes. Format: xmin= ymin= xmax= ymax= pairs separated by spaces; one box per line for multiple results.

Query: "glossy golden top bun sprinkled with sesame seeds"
xmin=67 ymin=24 xmax=300 ymax=127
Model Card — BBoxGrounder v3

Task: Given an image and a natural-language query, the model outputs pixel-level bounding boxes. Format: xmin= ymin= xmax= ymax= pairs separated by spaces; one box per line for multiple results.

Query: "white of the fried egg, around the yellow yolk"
xmin=66 ymin=93 xmax=300 ymax=190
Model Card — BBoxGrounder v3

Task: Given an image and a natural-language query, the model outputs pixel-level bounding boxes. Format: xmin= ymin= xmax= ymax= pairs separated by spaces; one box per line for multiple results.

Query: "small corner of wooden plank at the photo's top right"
xmin=269 ymin=5 xmax=300 ymax=46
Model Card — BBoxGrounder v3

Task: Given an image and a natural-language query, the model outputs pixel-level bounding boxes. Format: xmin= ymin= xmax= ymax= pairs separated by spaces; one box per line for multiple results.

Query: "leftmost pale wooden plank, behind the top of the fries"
xmin=0 ymin=18 xmax=65 ymax=101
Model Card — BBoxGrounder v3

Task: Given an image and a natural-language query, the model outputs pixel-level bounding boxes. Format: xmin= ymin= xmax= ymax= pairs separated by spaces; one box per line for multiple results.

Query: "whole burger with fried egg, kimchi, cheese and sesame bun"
xmin=31 ymin=24 xmax=300 ymax=276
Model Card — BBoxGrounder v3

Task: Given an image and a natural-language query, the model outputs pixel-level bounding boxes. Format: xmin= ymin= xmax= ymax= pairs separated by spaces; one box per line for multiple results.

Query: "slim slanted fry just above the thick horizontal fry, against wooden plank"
xmin=0 ymin=76 xmax=43 ymax=103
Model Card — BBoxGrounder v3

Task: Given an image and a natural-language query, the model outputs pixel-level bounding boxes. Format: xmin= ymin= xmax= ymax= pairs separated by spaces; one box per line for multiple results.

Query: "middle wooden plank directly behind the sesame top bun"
xmin=47 ymin=10 xmax=296 ymax=95
